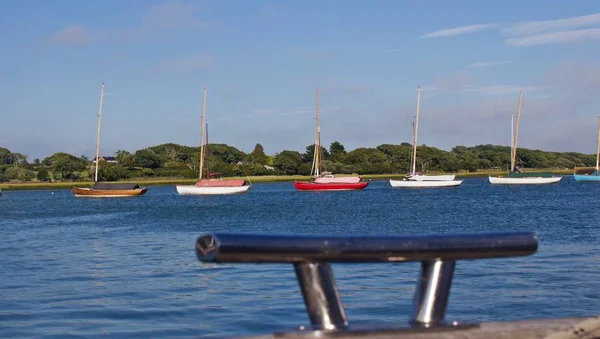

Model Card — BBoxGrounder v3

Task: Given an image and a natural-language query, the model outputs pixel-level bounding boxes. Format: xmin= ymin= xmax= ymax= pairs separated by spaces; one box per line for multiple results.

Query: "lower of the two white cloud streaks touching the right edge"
xmin=505 ymin=28 xmax=600 ymax=46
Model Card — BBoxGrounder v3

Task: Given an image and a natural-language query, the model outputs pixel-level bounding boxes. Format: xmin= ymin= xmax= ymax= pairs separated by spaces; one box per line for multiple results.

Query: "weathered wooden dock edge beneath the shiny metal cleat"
xmin=245 ymin=316 xmax=600 ymax=339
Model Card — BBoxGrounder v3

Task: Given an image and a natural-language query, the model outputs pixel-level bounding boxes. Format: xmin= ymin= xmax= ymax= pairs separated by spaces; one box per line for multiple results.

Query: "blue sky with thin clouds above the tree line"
xmin=0 ymin=0 xmax=600 ymax=161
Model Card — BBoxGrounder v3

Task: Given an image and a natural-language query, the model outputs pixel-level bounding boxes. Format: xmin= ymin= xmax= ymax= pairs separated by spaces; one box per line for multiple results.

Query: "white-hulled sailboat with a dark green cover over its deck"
xmin=489 ymin=88 xmax=562 ymax=185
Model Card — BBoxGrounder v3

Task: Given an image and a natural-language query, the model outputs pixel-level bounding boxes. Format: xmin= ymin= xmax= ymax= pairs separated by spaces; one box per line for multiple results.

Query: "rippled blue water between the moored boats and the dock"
xmin=0 ymin=177 xmax=600 ymax=338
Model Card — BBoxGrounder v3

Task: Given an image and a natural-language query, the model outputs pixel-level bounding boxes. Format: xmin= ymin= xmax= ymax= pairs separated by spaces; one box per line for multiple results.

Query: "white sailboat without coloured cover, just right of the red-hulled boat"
xmin=390 ymin=87 xmax=462 ymax=188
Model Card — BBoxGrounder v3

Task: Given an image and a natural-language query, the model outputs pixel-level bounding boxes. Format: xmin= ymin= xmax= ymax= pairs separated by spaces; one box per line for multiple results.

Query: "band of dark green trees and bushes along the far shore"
xmin=0 ymin=141 xmax=596 ymax=187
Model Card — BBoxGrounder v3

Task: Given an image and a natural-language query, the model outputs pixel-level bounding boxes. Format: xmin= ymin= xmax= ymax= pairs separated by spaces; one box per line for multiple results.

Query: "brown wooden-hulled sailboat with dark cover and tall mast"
xmin=73 ymin=83 xmax=148 ymax=198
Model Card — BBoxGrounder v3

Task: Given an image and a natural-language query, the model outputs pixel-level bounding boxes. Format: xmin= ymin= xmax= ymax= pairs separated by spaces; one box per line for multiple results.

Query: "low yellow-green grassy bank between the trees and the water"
xmin=0 ymin=169 xmax=573 ymax=191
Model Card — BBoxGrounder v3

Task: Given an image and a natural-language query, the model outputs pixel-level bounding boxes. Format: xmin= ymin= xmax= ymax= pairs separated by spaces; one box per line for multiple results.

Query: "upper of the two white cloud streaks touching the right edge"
xmin=502 ymin=13 xmax=600 ymax=35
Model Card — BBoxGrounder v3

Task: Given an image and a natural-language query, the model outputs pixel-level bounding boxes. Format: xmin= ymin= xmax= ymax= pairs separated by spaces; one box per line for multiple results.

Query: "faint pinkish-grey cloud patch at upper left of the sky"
xmin=47 ymin=0 xmax=215 ymax=46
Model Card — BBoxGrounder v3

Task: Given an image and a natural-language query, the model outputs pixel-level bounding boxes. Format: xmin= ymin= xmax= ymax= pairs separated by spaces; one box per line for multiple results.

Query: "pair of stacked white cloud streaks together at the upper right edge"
xmin=501 ymin=13 xmax=600 ymax=46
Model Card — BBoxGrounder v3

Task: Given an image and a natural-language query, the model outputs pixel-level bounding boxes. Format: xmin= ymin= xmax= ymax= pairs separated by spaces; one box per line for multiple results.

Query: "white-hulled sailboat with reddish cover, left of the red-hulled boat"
xmin=175 ymin=86 xmax=252 ymax=195
